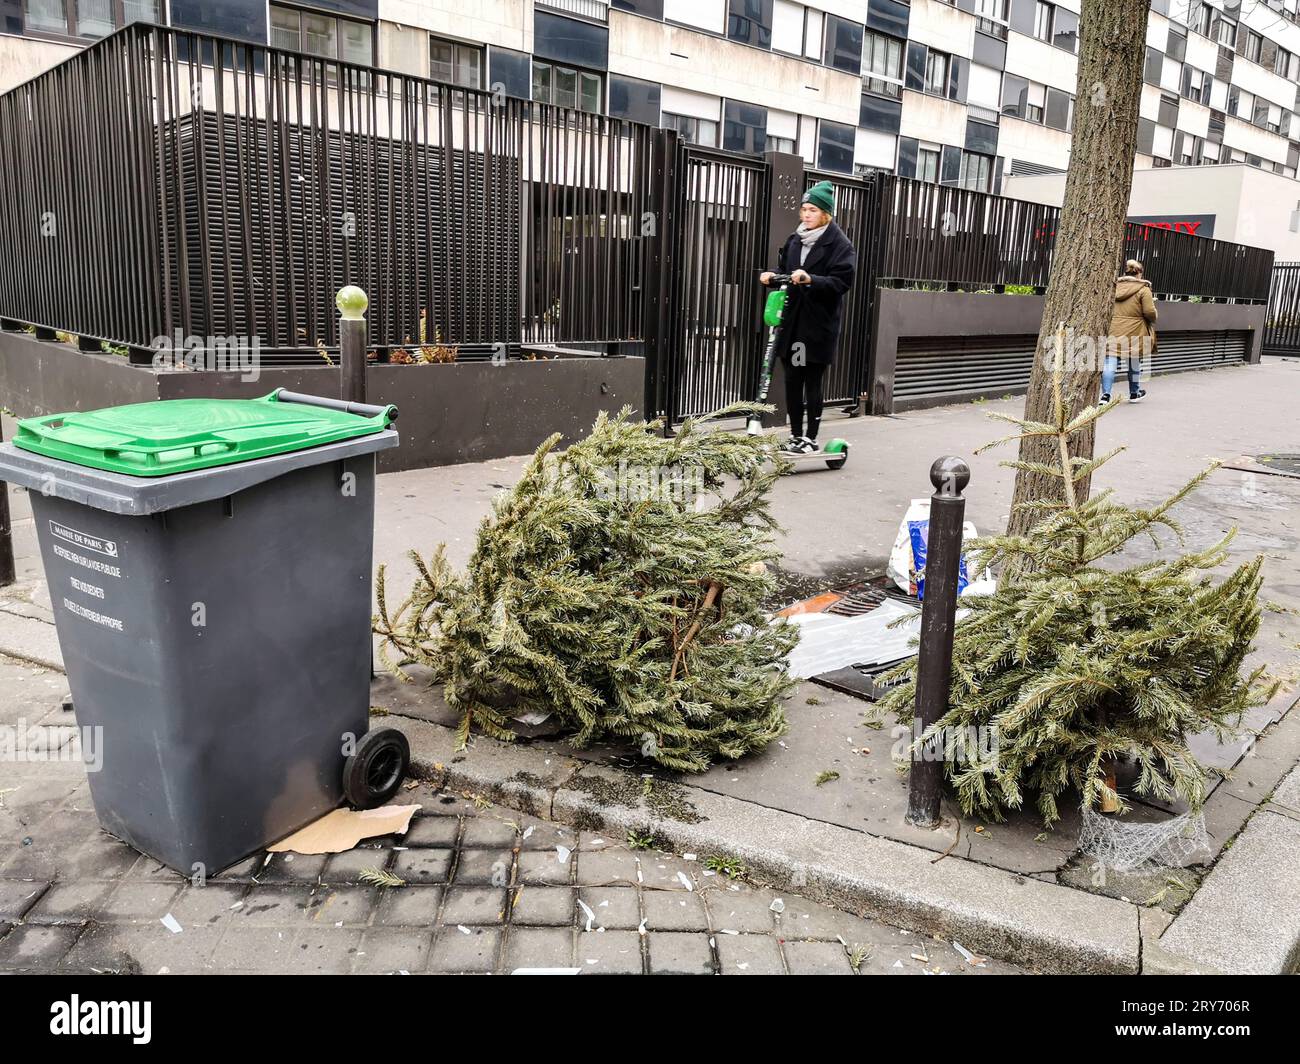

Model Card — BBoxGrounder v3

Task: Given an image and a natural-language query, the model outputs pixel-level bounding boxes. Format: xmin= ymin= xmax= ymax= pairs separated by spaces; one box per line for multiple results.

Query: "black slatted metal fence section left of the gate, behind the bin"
xmin=0 ymin=23 xmax=655 ymax=351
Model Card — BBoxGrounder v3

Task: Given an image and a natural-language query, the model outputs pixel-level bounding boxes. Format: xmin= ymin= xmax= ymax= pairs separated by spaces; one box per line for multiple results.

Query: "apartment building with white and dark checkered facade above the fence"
xmin=0 ymin=0 xmax=1300 ymax=191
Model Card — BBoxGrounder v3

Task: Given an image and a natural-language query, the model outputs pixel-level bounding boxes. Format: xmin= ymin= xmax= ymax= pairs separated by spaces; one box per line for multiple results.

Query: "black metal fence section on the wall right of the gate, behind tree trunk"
xmin=879 ymin=177 xmax=1273 ymax=303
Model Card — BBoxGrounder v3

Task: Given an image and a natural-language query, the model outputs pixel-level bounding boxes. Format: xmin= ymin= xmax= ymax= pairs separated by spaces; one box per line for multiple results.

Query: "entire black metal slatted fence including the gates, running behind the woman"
xmin=0 ymin=23 xmax=1279 ymax=423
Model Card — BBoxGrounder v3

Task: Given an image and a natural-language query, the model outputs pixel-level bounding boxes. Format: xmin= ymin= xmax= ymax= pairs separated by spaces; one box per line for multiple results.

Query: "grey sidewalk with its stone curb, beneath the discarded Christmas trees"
xmin=0 ymin=359 xmax=1300 ymax=972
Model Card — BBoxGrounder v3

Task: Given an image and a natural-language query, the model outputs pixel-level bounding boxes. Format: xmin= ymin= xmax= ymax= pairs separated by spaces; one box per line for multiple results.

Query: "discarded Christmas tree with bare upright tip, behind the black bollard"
xmin=881 ymin=372 xmax=1273 ymax=826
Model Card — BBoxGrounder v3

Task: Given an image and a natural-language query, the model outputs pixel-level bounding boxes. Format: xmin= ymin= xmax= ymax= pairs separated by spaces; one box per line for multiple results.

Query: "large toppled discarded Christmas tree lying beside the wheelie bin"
xmin=376 ymin=405 xmax=797 ymax=771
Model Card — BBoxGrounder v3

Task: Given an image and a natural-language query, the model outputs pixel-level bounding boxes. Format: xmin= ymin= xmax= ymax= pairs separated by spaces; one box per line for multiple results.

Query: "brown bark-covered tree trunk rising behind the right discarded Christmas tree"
xmin=1002 ymin=0 xmax=1151 ymax=581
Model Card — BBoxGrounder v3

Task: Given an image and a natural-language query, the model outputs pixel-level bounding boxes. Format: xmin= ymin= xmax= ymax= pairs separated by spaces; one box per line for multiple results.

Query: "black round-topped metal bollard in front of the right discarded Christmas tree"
xmin=907 ymin=455 xmax=971 ymax=827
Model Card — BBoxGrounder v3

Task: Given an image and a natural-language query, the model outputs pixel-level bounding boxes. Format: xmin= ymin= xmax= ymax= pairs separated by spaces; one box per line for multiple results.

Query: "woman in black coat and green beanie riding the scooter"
xmin=759 ymin=181 xmax=858 ymax=454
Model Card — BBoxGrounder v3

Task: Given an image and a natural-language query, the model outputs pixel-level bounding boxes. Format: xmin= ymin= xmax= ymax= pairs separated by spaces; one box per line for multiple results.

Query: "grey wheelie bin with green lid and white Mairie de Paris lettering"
xmin=0 ymin=389 xmax=408 ymax=875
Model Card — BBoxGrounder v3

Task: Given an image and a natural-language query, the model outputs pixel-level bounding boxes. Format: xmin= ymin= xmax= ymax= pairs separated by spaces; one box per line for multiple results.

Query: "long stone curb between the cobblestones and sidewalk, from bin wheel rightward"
xmin=385 ymin=715 xmax=1144 ymax=974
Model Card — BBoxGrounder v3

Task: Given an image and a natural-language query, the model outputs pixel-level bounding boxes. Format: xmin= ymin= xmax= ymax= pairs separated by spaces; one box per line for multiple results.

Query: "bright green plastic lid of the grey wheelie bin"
xmin=13 ymin=389 xmax=397 ymax=476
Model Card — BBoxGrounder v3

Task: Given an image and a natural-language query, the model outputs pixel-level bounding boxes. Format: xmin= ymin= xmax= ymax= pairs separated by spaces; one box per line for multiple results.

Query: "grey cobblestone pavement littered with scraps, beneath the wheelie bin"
xmin=0 ymin=659 xmax=1017 ymax=976
